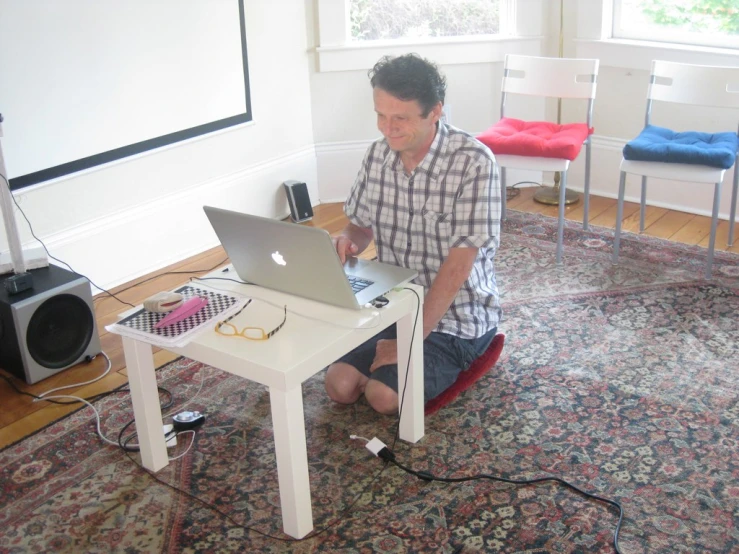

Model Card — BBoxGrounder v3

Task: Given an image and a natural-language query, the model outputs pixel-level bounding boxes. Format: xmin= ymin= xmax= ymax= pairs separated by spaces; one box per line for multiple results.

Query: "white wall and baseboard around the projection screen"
xmin=2 ymin=0 xmax=318 ymax=288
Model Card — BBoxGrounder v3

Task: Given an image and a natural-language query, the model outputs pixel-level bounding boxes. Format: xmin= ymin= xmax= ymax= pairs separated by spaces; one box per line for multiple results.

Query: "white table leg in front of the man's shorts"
xmin=396 ymin=300 xmax=424 ymax=442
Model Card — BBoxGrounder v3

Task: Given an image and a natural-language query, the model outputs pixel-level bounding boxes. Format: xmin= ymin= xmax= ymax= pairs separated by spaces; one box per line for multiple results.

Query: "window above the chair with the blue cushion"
xmin=613 ymin=0 xmax=739 ymax=48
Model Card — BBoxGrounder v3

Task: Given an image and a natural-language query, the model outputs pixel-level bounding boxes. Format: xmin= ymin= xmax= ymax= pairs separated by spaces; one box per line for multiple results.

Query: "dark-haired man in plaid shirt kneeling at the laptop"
xmin=325 ymin=54 xmax=501 ymax=414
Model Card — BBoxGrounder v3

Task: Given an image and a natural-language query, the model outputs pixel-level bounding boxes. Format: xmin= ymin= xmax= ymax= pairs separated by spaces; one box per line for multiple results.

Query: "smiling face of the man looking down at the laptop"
xmin=373 ymin=88 xmax=442 ymax=156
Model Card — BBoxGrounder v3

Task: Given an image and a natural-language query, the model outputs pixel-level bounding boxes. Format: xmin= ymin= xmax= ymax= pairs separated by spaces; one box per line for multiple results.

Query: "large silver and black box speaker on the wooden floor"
xmin=0 ymin=265 xmax=101 ymax=384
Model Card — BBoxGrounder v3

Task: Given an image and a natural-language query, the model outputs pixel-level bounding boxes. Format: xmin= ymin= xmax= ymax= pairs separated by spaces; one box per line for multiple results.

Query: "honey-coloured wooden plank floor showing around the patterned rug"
xmin=0 ymin=188 xmax=739 ymax=448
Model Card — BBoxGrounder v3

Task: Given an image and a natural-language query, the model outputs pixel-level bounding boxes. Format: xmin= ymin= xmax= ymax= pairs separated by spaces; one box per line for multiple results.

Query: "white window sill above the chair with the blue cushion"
xmin=575 ymin=39 xmax=739 ymax=71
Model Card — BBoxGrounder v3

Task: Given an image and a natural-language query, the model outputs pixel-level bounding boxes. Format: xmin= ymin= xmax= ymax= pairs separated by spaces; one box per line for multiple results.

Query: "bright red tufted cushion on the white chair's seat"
xmin=477 ymin=117 xmax=593 ymax=161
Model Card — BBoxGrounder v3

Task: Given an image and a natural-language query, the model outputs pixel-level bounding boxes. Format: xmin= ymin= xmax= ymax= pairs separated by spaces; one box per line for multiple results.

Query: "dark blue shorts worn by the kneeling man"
xmin=337 ymin=325 xmax=496 ymax=402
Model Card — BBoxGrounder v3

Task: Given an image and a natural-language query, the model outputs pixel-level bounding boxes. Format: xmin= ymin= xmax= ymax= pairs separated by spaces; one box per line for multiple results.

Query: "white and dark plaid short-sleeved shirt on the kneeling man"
xmin=344 ymin=122 xmax=501 ymax=339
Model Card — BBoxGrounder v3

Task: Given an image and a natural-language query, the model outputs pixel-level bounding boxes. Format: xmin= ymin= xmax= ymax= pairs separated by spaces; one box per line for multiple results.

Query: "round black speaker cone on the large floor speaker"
xmin=26 ymin=294 xmax=95 ymax=369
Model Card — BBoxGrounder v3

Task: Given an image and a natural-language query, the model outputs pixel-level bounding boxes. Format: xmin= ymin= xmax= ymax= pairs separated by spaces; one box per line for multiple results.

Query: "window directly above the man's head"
xmin=349 ymin=0 xmax=503 ymax=42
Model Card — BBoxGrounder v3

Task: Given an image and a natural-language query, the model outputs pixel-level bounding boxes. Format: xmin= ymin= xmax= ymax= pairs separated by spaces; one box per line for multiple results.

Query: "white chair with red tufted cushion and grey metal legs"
xmin=477 ymin=54 xmax=598 ymax=264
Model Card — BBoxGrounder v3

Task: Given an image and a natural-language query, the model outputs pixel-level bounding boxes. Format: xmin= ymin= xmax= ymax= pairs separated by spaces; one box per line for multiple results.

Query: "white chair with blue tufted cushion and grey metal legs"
xmin=613 ymin=60 xmax=739 ymax=279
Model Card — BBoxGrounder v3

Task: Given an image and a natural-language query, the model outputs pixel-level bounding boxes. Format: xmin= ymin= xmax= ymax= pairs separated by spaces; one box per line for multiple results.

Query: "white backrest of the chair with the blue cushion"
xmin=647 ymin=60 xmax=739 ymax=108
